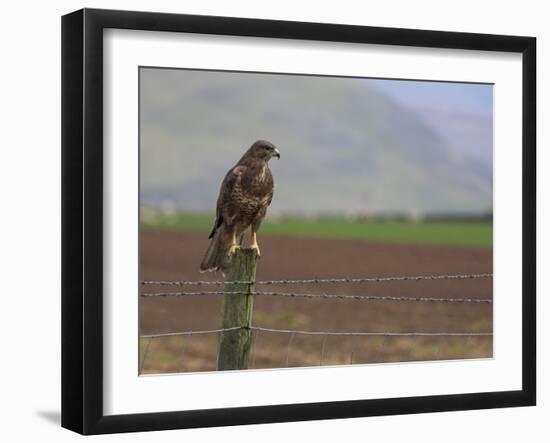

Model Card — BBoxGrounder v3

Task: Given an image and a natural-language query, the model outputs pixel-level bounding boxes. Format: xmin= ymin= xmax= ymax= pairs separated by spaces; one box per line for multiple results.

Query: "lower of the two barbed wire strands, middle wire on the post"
xmin=140 ymin=291 xmax=493 ymax=304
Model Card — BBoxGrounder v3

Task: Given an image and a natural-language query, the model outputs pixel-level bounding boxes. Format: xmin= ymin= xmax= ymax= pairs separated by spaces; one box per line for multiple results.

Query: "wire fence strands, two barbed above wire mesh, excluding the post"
xmin=140 ymin=273 xmax=493 ymax=373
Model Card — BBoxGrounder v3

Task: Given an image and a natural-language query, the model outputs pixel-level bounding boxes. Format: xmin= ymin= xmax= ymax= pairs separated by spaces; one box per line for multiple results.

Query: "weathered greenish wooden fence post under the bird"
xmin=218 ymin=248 xmax=257 ymax=371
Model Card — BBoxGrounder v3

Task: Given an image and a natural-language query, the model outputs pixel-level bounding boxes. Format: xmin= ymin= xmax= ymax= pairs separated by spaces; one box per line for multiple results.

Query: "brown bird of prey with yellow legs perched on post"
xmin=200 ymin=140 xmax=281 ymax=272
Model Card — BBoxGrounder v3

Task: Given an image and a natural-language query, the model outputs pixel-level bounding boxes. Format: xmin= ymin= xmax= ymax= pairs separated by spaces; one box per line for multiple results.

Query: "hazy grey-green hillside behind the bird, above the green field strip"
xmin=140 ymin=70 xmax=492 ymax=214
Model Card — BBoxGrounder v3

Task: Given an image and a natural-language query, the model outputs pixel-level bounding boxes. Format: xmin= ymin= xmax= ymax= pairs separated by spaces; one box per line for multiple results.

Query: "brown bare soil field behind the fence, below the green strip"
xmin=140 ymin=230 xmax=492 ymax=373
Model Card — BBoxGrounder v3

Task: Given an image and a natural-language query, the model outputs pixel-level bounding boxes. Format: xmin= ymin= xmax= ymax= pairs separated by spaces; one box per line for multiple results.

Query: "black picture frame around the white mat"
xmin=62 ymin=9 xmax=536 ymax=434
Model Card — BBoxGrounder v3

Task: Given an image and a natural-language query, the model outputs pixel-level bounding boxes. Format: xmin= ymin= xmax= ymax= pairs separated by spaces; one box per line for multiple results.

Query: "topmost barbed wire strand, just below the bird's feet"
xmin=141 ymin=273 xmax=493 ymax=286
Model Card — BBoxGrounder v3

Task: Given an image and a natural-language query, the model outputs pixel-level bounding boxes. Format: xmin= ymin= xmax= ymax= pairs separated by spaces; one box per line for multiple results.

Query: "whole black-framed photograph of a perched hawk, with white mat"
xmin=62 ymin=9 xmax=536 ymax=434
